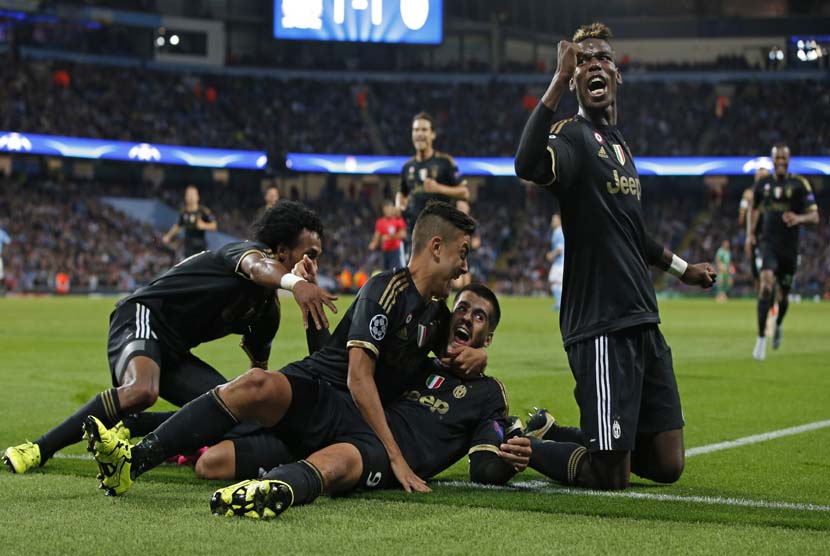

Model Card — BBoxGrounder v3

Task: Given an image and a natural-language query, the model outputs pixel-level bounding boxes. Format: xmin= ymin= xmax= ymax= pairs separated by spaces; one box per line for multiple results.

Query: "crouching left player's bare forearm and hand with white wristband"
xmin=239 ymin=252 xmax=337 ymax=330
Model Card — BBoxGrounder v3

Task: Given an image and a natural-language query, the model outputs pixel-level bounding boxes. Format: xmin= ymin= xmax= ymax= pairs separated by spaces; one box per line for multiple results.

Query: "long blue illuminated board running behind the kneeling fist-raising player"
xmin=285 ymin=153 xmax=830 ymax=176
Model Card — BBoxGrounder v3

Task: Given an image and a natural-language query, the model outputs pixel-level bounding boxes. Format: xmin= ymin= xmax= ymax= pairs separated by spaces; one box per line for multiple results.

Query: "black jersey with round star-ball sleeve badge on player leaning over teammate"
xmin=294 ymin=268 xmax=450 ymax=401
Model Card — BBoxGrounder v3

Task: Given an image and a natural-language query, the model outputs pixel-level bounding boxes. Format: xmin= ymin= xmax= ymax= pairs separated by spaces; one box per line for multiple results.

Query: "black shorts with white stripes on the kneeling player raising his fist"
xmin=567 ymin=324 xmax=684 ymax=451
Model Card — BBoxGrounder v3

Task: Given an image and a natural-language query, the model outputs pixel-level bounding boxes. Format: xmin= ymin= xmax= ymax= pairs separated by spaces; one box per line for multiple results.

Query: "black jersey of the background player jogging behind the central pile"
xmin=400 ymin=151 xmax=461 ymax=226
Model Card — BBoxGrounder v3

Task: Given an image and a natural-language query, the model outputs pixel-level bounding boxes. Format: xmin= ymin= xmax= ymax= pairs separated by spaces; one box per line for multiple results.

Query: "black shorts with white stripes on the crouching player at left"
xmin=107 ymin=302 xmax=226 ymax=407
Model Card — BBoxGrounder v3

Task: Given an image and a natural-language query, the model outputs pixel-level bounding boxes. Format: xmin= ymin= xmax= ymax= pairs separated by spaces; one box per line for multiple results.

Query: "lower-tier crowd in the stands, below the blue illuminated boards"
xmin=0 ymin=178 xmax=830 ymax=296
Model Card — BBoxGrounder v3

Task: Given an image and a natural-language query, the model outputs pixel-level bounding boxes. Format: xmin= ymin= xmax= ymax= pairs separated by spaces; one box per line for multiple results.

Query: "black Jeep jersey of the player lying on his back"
xmin=385 ymin=361 xmax=508 ymax=478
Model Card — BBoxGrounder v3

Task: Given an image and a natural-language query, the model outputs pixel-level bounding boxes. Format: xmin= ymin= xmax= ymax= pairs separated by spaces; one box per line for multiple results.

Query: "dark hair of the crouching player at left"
xmin=251 ymin=199 xmax=323 ymax=249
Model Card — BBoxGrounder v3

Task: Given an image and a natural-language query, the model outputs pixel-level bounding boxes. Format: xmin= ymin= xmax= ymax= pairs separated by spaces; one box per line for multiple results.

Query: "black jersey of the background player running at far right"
xmin=753 ymin=174 xmax=818 ymax=254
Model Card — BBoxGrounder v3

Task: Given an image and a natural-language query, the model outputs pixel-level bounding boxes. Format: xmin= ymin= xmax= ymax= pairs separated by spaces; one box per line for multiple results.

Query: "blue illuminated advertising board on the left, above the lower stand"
xmin=0 ymin=131 xmax=268 ymax=170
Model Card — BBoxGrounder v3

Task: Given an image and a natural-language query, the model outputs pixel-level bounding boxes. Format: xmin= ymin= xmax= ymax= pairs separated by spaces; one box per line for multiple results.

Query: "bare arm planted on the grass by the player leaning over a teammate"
xmin=347 ymin=347 xmax=431 ymax=492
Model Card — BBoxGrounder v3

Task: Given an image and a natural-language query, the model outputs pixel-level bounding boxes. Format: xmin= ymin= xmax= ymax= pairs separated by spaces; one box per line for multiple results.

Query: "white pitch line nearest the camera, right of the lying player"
xmin=437 ymin=481 xmax=830 ymax=512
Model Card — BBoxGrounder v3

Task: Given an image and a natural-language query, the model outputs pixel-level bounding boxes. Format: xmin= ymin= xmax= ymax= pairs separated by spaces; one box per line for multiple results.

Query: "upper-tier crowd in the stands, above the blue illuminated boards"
xmin=0 ymin=61 xmax=830 ymax=165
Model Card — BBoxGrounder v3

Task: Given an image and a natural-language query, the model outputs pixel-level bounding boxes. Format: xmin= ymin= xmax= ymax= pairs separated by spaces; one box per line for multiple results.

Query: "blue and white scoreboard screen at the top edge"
xmin=274 ymin=0 xmax=444 ymax=44
